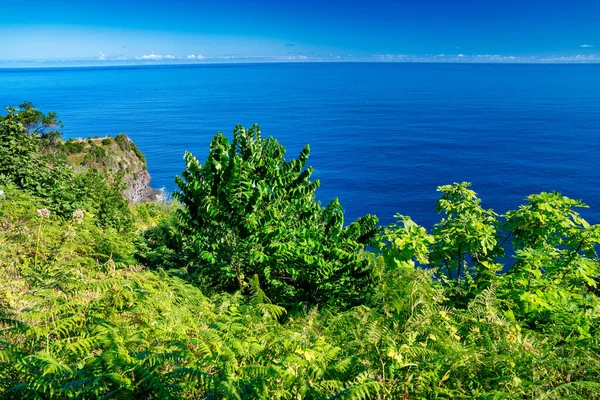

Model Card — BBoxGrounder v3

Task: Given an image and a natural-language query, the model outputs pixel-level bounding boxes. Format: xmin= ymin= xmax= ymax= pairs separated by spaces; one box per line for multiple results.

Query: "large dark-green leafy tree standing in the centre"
xmin=175 ymin=126 xmax=377 ymax=306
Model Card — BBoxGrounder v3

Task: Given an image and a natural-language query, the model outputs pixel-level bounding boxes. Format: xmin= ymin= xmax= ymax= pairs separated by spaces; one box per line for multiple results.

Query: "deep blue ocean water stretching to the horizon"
xmin=0 ymin=63 xmax=600 ymax=227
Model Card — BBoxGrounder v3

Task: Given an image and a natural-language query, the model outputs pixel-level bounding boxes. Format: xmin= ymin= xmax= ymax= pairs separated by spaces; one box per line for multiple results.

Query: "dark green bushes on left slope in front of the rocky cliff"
xmin=0 ymin=104 xmax=133 ymax=230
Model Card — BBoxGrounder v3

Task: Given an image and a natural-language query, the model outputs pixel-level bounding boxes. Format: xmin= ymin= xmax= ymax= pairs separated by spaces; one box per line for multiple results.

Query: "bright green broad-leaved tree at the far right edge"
xmin=505 ymin=192 xmax=600 ymax=336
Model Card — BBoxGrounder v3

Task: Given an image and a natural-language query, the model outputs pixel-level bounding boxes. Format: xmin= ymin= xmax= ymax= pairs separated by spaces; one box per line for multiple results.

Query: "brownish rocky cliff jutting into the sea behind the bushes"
xmin=64 ymin=134 xmax=163 ymax=203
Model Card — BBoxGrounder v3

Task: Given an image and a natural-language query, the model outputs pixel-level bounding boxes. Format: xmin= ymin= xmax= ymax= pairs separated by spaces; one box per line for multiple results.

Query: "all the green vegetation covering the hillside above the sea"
xmin=0 ymin=103 xmax=600 ymax=399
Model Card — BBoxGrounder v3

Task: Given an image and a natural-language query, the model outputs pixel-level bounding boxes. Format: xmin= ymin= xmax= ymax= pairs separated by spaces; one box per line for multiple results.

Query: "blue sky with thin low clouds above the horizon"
xmin=0 ymin=0 xmax=600 ymax=62
